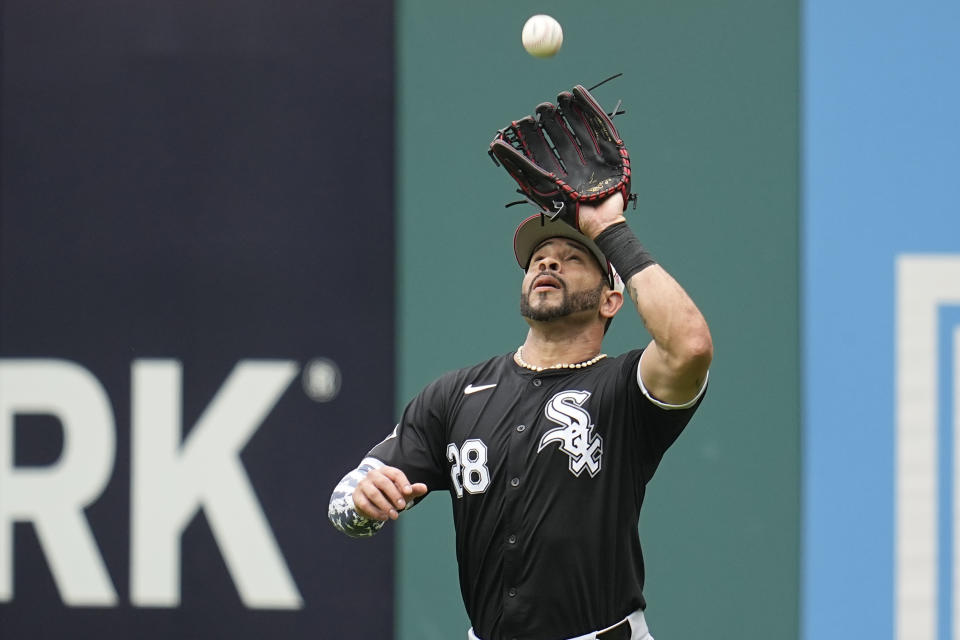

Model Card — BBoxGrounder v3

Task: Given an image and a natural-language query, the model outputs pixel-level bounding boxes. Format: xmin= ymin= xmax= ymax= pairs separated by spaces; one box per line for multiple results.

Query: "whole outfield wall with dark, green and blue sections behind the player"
xmin=0 ymin=0 xmax=960 ymax=640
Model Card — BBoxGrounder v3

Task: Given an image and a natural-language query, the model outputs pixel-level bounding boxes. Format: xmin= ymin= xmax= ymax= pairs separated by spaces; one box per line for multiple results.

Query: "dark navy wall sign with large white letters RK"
xmin=0 ymin=0 xmax=394 ymax=638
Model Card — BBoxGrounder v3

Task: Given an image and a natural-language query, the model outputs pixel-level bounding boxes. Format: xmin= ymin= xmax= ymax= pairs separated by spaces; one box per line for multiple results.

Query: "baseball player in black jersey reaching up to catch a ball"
xmin=329 ymin=86 xmax=713 ymax=640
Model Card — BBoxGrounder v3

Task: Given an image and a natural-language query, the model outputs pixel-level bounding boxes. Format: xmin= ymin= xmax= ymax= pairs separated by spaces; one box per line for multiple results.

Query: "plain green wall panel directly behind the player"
xmin=397 ymin=0 xmax=800 ymax=640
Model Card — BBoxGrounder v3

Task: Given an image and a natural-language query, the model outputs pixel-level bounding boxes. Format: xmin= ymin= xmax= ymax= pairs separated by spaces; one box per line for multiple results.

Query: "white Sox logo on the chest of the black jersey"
xmin=537 ymin=391 xmax=603 ymax=478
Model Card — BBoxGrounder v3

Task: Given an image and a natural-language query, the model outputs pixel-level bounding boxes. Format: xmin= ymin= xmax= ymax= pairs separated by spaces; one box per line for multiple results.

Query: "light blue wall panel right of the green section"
xmin=801 ymin=0 xmax=960 ymax=640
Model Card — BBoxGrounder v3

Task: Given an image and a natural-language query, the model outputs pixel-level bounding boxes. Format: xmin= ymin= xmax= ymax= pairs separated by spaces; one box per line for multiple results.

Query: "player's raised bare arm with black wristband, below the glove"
xmin=579 ymin=193 xmax=713 ymax=405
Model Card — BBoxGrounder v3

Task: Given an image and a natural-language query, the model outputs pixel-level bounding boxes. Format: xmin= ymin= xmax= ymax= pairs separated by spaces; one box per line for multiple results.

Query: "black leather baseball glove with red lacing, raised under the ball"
xmin=490 ymin=85 xmax=630 ymax=230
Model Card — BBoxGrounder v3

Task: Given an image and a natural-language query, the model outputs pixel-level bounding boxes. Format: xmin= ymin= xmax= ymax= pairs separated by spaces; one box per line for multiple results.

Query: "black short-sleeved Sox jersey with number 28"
xmin=369 ymin=350 xmax=702 ymax=640
